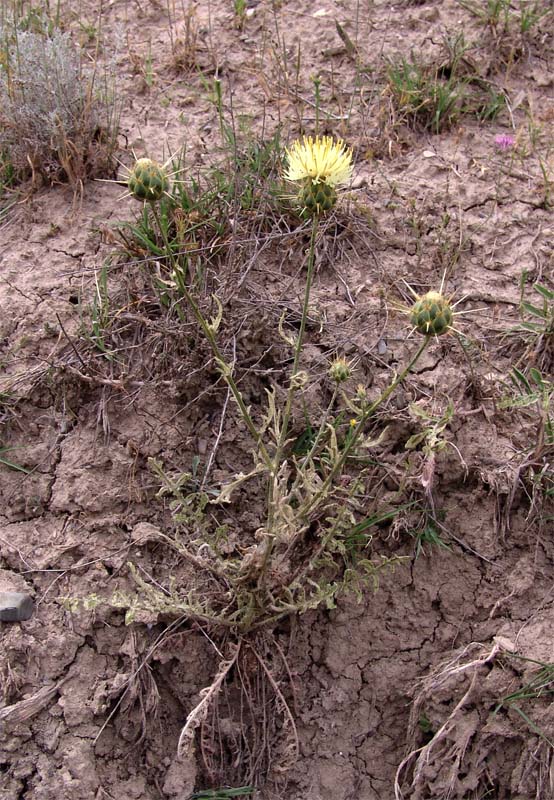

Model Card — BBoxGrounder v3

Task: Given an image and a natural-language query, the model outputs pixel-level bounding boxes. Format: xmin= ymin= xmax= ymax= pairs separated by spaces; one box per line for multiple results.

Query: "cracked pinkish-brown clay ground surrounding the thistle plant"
xmin=0 ymin=0 xmax=554 ymax=800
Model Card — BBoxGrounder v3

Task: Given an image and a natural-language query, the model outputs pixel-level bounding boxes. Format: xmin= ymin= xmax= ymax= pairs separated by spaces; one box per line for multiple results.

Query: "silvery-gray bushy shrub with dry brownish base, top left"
xmin=0 ymin=30 xmax=117 ymax=182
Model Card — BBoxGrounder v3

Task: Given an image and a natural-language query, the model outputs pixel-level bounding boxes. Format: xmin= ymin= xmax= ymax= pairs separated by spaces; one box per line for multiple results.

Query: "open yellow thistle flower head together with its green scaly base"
xmin=284 ymin=136 xmax=352 ymax=215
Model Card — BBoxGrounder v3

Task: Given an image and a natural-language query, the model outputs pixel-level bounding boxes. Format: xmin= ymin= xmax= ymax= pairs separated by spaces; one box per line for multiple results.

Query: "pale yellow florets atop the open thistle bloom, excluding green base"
xmin=285 ymin=136 xmax=352 ymax=187
